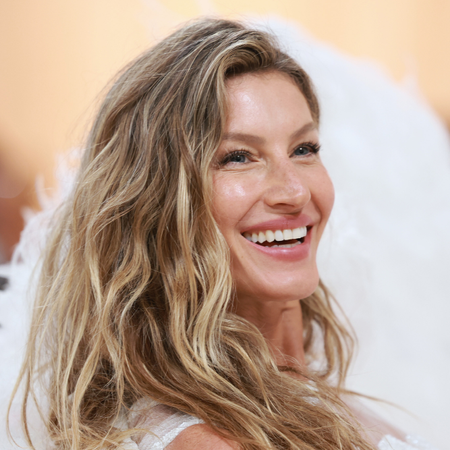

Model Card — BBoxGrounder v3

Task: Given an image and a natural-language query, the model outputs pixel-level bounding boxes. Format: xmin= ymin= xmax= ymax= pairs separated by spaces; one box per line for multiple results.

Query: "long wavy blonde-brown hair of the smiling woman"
xmin=12 ymin=19 xmax=372 ymax=450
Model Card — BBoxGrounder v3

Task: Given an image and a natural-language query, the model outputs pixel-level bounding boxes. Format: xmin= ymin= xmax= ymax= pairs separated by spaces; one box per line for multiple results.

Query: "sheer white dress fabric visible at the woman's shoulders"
xmin=121 ymin=399 xmax=436 ymax=450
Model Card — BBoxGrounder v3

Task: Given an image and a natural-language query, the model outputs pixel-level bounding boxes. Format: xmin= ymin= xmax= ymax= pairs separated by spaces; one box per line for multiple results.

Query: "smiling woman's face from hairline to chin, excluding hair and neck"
xmin=213 ymin=72 xmax=334 ymax=303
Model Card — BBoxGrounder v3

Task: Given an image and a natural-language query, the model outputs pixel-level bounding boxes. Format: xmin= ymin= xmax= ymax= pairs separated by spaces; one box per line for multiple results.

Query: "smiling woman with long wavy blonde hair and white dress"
xmin=11 ymin=20 xmax=428 ymax=450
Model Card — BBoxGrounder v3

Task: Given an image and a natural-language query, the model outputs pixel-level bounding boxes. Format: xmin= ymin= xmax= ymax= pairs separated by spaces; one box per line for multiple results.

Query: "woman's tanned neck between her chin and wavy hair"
xmin=236 ymin=300 xmax=305 ymax=368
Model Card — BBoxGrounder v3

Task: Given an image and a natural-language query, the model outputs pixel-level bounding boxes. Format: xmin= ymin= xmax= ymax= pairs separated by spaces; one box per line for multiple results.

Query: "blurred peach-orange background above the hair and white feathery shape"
xmin=0 ymin=0 xmax=450 ymax=263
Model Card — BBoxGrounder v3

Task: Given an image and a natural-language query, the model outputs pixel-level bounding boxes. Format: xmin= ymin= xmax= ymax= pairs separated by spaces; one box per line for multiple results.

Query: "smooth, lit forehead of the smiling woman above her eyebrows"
xmin=226 ymin=71 xmax=313 ymax=134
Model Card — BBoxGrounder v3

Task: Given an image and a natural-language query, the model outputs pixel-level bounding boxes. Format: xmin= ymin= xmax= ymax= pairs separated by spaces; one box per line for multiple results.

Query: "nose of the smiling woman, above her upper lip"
xmin=264 ymin=158 xmax=311 ymax=213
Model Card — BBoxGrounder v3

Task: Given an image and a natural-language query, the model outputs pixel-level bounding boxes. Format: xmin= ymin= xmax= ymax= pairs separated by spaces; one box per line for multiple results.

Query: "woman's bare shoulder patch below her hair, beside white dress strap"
xmin=166 ymin=424 xmax=239 ymax=450
